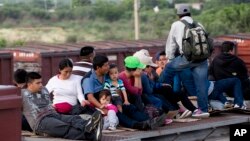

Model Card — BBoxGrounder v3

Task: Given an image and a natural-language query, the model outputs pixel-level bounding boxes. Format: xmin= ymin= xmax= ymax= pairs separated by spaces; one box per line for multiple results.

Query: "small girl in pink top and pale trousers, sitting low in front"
xmin=99 ymin=89 xmax=119 ymax=130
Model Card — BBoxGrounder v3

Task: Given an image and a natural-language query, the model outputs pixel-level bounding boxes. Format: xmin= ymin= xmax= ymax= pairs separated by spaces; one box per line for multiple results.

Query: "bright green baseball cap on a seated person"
xmin=124 ymin=56 xmax=146 ymax=69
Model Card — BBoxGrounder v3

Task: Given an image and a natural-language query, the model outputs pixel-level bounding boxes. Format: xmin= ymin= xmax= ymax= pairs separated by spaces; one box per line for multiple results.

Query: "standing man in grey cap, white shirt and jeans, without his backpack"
xmin=165 ymin=5 xmax=209 ymax=117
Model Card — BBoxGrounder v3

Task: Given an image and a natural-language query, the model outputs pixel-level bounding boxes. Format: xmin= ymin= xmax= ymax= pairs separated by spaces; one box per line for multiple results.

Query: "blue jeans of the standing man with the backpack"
xmin=159 ymin=55 xmax=208 ymax=112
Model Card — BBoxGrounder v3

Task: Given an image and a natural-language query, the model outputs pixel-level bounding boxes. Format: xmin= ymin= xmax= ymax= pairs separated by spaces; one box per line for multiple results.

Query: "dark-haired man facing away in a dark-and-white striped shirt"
xmin=72 ymin=46 xmax=95 ymax=76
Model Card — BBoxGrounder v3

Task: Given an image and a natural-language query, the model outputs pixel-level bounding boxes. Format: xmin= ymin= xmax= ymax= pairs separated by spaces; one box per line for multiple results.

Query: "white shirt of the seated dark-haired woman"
xmin=46 ymin=74 xmax=85 ymax=106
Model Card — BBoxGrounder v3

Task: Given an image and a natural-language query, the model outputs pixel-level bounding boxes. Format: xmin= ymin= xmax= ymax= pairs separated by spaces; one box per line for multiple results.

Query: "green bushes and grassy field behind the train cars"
xmin=0 ymin=0 xmax=250 ymax=42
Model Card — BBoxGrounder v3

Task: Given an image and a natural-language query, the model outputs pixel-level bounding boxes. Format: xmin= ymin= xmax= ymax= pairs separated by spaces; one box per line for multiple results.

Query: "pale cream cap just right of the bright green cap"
xmin=133 ymin=50 xmax=158 ymax=67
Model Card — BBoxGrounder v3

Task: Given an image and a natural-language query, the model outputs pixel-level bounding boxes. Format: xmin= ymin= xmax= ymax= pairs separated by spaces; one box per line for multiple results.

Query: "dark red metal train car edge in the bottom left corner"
xmin=0 ymin=86 xmax=22 ymax=141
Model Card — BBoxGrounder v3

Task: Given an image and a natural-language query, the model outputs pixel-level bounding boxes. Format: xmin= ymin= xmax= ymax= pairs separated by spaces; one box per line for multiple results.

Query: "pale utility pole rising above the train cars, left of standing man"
xmin=134 ymin=0 xmax=140 ymax=40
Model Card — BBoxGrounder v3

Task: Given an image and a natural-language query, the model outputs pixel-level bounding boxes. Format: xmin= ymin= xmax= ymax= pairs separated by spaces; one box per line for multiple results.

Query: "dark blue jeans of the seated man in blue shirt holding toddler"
xmin=117 ymin=104 xmax=149 ymax=128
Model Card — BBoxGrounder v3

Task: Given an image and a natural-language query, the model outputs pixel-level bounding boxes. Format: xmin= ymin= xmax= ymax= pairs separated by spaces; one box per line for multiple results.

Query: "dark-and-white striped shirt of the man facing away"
xmin=72 ymin=61 xmax=92 ymax=76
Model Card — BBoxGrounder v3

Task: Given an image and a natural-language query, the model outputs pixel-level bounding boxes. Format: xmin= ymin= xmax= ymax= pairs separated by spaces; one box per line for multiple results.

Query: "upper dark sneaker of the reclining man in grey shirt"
xmin=85 ymin=111 xmax=102 ymax=133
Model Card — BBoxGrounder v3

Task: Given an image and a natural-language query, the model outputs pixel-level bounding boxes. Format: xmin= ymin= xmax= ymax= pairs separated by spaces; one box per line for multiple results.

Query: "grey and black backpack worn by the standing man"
xmin=181 ymin=20 xmax=212 ymax=62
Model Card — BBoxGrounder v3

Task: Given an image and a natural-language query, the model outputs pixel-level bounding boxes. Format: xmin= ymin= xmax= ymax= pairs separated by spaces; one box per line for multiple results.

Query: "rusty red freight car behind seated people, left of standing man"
xmin=1 ymin=40 xmax=165 ymax=83
